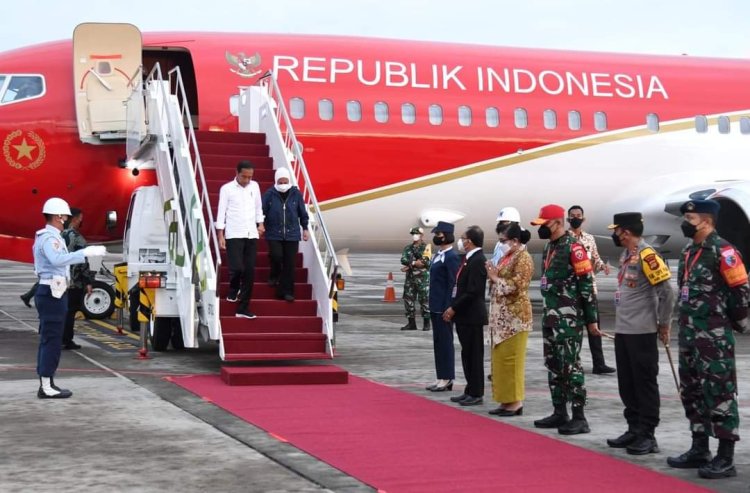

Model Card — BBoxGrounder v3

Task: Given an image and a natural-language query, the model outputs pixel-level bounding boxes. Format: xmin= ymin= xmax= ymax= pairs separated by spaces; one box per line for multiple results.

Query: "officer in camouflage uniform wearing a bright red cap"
xmin=531 ymin=204 xmax=601 ymax=435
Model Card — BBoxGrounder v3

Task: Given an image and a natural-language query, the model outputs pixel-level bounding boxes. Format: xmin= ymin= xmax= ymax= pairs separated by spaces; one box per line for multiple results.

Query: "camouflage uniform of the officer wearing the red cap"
xmin=541 ymin=234 xmax=597 ymax=409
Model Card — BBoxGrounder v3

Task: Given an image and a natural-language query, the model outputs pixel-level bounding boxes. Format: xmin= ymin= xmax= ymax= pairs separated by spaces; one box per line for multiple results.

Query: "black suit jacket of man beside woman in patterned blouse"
xmin=451 ymin=250 xmax=488 ymax=325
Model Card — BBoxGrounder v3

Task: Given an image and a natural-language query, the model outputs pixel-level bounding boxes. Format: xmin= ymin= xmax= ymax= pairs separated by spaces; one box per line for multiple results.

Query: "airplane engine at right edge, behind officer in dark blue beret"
xmin=709 ymin=182 xmax=750 ymax=265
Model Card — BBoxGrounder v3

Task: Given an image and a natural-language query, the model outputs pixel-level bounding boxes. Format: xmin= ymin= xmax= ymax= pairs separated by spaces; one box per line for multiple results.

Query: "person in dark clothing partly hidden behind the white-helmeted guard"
xmin=62 ymin=207 xmax=95 ymax=349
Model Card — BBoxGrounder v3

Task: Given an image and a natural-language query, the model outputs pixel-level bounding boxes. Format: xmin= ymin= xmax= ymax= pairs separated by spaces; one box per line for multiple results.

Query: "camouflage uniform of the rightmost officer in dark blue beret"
xmin=677 ymin=231 xmax=750 ymax=441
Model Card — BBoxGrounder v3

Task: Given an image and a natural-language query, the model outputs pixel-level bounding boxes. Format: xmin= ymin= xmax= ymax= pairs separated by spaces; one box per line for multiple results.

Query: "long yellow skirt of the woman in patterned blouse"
xmin=492 ymin=331 xmax=529 ymax=404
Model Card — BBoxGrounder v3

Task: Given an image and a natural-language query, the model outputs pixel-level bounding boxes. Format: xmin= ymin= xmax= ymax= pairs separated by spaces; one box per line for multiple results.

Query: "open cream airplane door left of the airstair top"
xmin=73 ymin=23 xmax=142 ymax=144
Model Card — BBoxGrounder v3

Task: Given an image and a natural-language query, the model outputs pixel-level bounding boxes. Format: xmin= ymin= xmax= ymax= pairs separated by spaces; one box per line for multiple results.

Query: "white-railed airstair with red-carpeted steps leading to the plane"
xmin=127 ymin=65 xmax=339 ymax=366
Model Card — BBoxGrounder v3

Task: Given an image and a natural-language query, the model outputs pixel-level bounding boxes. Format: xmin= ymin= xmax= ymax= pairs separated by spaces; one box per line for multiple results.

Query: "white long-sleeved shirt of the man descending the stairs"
xmin=216 ymin=178 xmax=263 ymax=240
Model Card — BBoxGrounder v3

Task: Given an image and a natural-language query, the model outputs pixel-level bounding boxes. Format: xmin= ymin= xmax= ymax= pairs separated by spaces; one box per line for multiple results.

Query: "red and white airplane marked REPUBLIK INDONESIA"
xmin=0 ymin=26 xmax=750 ymax=262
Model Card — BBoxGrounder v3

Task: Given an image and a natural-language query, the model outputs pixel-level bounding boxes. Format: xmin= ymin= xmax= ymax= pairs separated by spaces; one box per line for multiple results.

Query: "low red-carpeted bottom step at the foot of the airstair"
xmin=221 ymin=365 xmax=349 ymax=385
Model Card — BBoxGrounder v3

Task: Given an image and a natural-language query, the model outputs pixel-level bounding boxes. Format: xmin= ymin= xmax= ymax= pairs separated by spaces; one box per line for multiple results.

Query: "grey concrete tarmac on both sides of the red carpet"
xmin=0 ymin=254 xmax=750 ymax=492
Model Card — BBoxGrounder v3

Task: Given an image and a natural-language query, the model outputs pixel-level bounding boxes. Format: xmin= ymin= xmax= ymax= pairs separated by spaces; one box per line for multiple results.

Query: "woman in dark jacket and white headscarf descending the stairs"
xmin=263 ymin=168 xmax=310 ymax=301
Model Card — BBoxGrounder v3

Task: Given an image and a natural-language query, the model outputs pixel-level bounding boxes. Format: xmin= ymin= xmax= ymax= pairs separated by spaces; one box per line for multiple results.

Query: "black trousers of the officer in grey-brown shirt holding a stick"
xmin=615 ymin=333 xmax=660 ymax=434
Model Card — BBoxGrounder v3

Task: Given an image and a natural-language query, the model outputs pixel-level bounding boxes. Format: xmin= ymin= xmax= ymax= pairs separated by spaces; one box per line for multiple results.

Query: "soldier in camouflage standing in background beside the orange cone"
xmin=401 ymin=227 xmax=432 ymax=330
